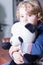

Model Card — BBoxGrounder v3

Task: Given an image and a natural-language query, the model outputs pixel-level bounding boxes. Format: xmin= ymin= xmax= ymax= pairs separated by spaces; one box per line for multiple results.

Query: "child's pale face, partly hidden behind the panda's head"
xmin=19 ymin=8 xmax=37 ymax=25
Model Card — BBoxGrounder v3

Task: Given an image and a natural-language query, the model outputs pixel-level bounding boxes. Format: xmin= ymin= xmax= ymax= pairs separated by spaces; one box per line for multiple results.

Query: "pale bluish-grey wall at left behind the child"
xmin=0 ymin=0 xmax=13 ymax=38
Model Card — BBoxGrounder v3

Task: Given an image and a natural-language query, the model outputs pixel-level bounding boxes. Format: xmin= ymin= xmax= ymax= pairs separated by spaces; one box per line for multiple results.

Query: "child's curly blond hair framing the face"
xmin=16 ymin=0 xmax=43 ymax=23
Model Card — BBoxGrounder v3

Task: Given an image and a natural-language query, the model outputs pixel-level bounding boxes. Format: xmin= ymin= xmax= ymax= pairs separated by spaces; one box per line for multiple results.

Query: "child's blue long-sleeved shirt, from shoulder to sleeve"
xmin=30 ymin=23 xmax=43 ymax=55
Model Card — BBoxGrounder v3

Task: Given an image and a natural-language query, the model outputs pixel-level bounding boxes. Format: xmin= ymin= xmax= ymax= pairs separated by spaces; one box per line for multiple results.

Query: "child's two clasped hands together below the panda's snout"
xmin=9 ymin=46 xmax=24 ymax=64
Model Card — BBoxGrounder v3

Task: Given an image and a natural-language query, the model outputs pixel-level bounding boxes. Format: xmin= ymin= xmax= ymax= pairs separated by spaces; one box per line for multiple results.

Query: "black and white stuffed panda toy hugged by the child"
xmin=2 ymin=22 xmax=40 ymax=65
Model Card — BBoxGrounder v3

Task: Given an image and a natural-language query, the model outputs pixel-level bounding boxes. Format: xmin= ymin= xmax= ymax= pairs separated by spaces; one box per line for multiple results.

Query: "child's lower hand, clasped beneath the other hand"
xmin=13 ymin=52 xmax=24 ymax=64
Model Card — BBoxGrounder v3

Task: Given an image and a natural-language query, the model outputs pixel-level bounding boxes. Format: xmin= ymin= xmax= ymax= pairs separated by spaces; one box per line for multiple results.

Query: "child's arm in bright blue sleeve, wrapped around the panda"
xmin=31 ymin=32 xmax=43 ymax=55
